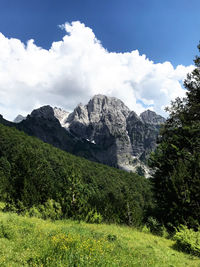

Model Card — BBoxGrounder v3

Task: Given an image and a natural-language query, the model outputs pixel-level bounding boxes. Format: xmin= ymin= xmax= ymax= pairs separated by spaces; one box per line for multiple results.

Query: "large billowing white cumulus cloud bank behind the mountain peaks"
xmin=0 ymin=21 xmax=193 ymax=119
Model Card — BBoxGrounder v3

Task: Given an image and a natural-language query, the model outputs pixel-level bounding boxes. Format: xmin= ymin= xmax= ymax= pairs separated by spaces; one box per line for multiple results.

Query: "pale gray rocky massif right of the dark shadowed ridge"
xmin=58 ymin=95 xmax=165 ymax=176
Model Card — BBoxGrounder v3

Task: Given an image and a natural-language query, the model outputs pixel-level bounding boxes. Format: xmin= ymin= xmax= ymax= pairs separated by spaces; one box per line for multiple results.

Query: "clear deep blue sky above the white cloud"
xmin=0 ymin=0 xmax=200 ymax=66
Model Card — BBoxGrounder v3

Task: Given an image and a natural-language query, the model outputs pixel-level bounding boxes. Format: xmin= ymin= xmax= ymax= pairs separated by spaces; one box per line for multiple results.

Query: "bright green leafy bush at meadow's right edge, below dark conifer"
xmin=174 ymin=225 xmax=200 ymax=257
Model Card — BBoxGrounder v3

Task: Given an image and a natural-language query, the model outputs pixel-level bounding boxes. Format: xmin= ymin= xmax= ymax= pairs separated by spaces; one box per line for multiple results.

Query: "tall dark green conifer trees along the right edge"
xmin=150 ymin=43 xmax=200 ymax=229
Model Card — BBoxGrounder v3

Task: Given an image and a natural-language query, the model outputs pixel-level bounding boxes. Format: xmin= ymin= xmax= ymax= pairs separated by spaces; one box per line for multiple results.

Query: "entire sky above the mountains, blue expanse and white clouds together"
xmin=0 ymin=0 xmax=200 ymax=120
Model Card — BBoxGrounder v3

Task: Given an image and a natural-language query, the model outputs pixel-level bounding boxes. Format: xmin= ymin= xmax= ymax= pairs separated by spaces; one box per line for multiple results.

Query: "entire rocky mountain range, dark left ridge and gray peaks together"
xmin=2 ymin=95 xmax=165 ymax=176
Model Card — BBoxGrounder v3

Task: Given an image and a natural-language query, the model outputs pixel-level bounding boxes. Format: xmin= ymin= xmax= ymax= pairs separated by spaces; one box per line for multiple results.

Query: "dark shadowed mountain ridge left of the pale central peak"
xmin=14 ymin=105 xmax=99 ymax=162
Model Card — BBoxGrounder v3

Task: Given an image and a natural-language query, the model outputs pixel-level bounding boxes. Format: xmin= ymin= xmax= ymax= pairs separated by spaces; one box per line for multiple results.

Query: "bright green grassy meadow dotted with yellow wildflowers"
xmin=0 ymin=212 xmax=200 ymax=267
